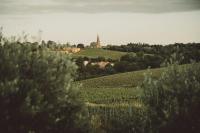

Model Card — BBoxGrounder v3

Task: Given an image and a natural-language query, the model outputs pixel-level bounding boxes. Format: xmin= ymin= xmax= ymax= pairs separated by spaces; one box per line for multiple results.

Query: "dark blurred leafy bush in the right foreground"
xmin=142 ymin=64 xmax=200 ymax=133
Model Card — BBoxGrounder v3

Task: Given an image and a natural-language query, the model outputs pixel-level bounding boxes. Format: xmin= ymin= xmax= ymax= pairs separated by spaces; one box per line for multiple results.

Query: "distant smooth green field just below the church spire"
xmin=72 ymin=48 xmax=127 ymax=60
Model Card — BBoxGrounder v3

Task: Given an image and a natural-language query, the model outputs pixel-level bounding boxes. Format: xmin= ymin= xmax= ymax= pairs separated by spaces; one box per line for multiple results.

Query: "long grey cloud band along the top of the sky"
xmin=0 ymin=0 xmax=200 ymax=14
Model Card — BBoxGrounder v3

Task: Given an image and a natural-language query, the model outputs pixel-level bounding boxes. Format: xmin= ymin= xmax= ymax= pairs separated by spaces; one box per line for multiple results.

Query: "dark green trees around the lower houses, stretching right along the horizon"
xmin=76 ymin=43 xmax=200 ymax=80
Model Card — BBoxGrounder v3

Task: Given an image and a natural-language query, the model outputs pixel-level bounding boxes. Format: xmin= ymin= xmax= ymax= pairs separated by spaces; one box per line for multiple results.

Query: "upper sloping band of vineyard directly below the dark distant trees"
xmin=80 ymin=68 xmax=163 ymax=88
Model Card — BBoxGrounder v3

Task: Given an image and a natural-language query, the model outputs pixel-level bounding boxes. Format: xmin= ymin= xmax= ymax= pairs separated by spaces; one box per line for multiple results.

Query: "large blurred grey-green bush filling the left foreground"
xmin=0 ymin=42 xmax=87 ymax=133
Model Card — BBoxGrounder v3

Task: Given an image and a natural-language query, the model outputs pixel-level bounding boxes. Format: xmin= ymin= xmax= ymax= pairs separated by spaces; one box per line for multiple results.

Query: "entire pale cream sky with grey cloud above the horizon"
xmin=0 ymin=0 xmax=200 ymax=45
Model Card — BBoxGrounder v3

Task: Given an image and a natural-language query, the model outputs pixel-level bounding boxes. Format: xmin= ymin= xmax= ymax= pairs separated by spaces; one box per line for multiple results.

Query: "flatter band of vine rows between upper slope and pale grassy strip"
xmin=81 ymin=88 xmax=141 ymax=104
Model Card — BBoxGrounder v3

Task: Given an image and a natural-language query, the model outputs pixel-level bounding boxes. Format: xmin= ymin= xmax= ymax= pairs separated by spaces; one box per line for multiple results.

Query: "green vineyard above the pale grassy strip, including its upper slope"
xmin=78 ymin=68 xmax=163 ymax=104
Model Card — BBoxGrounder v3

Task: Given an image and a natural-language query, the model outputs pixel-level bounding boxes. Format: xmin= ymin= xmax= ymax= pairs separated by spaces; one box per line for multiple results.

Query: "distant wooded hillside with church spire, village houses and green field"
xmin=42 ymin=35 xmax=200 ymax=80
